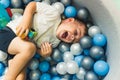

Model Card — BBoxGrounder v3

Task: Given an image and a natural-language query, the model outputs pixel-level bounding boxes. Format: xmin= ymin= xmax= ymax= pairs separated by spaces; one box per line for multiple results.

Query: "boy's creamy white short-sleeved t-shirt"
xmin=7 ymin=2 xmax=61 ymax=48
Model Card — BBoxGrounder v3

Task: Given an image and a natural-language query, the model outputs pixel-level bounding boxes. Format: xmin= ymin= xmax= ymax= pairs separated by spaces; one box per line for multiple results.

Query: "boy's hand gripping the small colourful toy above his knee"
xmin=16 ymin=23 xmax=29 ymax=39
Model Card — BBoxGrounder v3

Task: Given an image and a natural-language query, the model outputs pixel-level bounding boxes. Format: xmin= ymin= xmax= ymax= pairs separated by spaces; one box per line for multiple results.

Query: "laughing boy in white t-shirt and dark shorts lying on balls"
xmin=0 ymin=2 xmax=85 ymax=80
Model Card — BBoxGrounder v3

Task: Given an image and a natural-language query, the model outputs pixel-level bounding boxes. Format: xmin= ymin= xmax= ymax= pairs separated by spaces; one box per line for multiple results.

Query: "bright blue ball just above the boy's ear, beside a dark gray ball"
xmin=64 ymin=6 xmax=77 ymax=18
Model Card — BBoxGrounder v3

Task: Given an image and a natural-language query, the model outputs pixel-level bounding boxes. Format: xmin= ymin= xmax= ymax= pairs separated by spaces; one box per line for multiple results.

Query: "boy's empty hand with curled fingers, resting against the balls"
xmin=40 ymin=42 xmax=52 ymax=57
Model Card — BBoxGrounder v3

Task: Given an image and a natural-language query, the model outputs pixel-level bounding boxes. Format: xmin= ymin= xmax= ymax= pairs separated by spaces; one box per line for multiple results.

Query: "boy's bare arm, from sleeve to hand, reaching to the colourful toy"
xmin=16 ymin=2 xmax=36 ymax=37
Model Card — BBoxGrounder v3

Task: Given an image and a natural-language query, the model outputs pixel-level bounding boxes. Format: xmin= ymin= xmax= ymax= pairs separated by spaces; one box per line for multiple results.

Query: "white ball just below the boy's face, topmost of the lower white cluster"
xmin=70 ymin=43 xmax=83 ymax=55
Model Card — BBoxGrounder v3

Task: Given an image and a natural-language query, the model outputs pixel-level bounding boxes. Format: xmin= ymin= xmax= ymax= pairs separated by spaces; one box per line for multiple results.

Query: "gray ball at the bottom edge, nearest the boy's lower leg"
xmin=29 ymin=70 xmax=41 ymax=80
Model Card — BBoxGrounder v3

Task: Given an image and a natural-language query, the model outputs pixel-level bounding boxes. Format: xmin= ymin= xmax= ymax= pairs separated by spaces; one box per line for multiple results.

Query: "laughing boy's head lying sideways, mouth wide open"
xmin=57 ymin=18 xmax=85 ymax=43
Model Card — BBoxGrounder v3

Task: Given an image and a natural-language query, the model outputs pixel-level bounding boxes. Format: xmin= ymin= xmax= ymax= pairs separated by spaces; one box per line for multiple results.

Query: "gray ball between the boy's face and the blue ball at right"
xmin=80 ymin=36 xmax=92 ymax=49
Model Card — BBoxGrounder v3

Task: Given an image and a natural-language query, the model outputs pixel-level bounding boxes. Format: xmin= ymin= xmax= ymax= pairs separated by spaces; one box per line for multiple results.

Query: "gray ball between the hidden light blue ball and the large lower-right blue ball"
xmin=81 ymin=56 xmax=94 ymax=70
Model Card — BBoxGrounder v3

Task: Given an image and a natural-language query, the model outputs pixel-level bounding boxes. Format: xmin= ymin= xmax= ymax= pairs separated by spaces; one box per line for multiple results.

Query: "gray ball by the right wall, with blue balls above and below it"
xmin=90 ymin=46 xmax=104 ymax=60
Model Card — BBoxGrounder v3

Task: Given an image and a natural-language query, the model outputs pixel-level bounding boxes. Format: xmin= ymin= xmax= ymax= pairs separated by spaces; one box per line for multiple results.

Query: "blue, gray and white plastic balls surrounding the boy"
xmin=0 ymin=0 xmax=110 ymax=80
